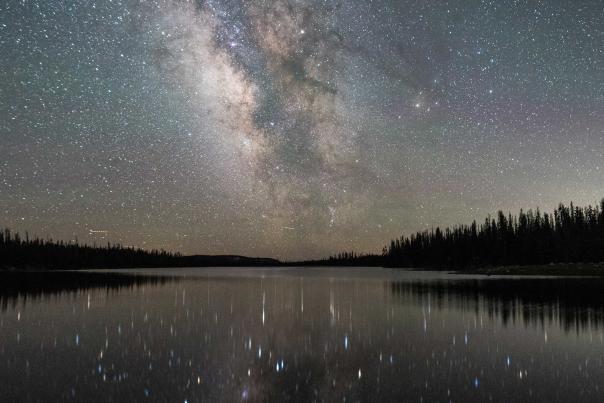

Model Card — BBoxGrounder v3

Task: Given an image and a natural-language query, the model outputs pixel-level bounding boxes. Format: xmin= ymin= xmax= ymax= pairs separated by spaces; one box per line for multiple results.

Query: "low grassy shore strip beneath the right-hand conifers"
xmin=455 ymin=262 xmax=604 ymax=277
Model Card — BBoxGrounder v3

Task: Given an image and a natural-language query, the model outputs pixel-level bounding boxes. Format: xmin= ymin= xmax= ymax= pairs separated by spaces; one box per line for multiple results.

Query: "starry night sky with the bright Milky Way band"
xmin=0 ymin=0 xmax=604 ymax=259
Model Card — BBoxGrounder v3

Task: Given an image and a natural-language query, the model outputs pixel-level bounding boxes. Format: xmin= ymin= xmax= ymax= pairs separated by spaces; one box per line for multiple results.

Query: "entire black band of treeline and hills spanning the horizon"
xmin=0 ymin=198 xmax=604 ymax=269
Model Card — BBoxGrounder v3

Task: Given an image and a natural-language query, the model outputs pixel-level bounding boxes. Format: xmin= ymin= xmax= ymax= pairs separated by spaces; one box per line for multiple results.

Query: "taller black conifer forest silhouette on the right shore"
xmin=383 ymin=199 xmax=604 ymax=267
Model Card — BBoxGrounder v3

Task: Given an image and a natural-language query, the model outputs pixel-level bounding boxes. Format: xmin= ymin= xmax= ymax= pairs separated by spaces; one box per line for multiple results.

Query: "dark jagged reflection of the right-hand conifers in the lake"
xmin=389 ymin=278 xmax=604 ymax=333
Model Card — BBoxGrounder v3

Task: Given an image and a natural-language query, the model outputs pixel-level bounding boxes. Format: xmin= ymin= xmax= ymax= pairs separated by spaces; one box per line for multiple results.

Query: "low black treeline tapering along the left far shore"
xmin=0 ymin=229 xmax=280 ymax=269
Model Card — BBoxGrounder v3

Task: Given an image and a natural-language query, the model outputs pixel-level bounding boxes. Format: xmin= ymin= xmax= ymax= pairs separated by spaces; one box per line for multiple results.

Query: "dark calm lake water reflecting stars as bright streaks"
xmin=0 ymin=268 xmax=604 ymax=402
